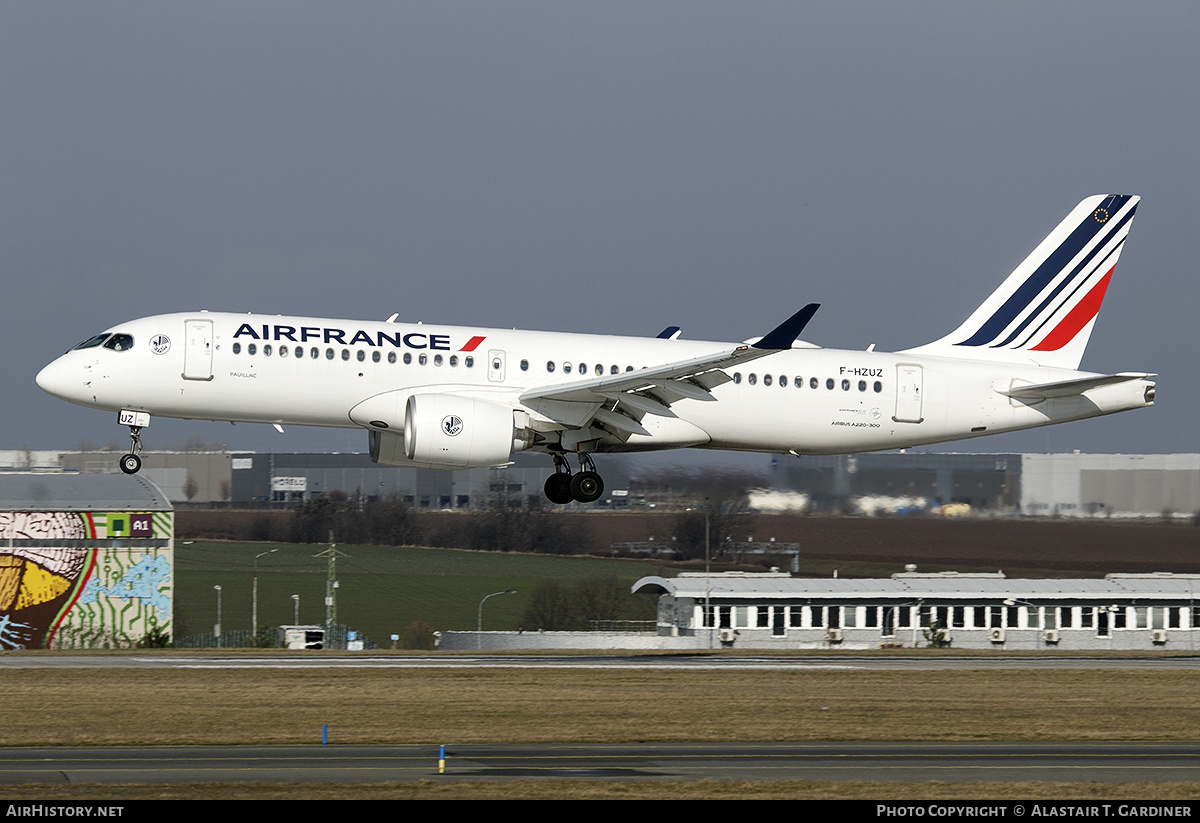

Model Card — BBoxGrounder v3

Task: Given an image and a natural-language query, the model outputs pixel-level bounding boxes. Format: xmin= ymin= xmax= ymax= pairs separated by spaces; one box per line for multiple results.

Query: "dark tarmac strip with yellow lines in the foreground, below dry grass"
xmin=0 ymin=743 xmax=1200 ymax=785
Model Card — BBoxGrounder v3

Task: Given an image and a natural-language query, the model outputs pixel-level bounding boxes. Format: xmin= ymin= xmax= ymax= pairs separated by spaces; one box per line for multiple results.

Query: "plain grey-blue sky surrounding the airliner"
xmin=0 ymin=0 xmax=1200 ymax=470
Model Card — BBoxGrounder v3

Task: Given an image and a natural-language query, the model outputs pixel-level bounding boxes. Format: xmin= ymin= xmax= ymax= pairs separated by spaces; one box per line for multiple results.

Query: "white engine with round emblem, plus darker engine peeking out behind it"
xmin=371 ymin=394 xmax=530 ymax=469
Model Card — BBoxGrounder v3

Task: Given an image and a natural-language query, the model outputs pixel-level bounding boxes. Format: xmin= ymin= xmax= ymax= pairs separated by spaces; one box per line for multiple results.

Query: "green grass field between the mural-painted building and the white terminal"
xmin=175 ymin=541 xmax=671 ymax=648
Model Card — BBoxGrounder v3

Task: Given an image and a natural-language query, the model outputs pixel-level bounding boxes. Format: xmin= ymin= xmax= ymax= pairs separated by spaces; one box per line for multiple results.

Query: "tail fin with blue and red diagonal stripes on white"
xmin=910 ymin=194 xmax=1140 ymax=368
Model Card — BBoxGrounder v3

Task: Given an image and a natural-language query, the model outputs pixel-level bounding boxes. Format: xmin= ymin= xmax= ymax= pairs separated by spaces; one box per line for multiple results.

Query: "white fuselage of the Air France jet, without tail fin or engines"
xmin=30 ymin=312 xmax=1153 ymax=455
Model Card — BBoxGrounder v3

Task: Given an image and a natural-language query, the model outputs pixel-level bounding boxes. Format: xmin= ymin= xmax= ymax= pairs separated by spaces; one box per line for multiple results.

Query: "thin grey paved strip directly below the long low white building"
xmin=0 ymin=653 xmax=1200 ymax=672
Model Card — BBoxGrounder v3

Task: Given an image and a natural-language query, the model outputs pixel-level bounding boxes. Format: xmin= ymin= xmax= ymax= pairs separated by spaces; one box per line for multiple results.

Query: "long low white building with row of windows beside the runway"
xmin=634 ymin=572 xmax=1200 ymax=651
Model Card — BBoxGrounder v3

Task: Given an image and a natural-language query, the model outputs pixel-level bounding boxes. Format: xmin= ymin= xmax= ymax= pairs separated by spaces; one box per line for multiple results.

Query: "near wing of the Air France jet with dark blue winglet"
xmin=521 ymin=304 xmax=818 ymax=435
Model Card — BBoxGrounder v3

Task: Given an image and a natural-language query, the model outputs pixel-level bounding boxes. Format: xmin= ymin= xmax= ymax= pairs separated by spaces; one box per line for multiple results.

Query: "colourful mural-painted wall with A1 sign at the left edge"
xmin=0 ymin=511 xmax=174 ymax=649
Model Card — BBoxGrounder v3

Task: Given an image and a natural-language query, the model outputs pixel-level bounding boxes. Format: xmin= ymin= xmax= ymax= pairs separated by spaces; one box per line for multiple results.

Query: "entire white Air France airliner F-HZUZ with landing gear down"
xmin=37 ymin=194 xmax=1154 ymax=503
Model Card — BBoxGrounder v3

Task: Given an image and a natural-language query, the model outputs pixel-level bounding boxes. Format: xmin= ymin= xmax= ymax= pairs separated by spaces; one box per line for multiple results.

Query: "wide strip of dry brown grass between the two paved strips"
xmin=9 ymin=669 xmax=1200 ymax=746
